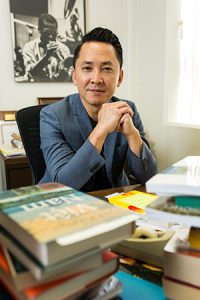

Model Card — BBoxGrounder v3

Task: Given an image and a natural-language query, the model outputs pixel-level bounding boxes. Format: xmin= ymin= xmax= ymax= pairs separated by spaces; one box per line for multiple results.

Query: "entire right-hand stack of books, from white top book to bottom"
xmin=146 ymin=156 xmax=200 ymax=300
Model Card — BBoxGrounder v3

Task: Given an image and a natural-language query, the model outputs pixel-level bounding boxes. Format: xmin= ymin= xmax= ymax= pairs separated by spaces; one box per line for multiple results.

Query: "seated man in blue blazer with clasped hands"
xmin=40 ymin=28 xmax=156 ymax=191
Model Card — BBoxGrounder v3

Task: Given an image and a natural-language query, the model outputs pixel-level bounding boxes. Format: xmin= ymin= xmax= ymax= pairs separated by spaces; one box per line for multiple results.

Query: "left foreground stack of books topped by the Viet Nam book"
xmin=0 ymin=183 xmax=138 ymax=300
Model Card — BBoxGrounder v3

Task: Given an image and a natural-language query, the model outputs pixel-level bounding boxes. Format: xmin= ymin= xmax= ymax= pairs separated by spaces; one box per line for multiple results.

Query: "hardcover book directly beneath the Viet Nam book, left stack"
xmin=0 ymin=234 xmax=102 ymax=282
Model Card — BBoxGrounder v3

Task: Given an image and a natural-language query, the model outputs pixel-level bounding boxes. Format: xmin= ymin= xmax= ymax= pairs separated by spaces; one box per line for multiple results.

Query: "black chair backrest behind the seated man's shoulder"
xmin=16 ymin=105 xmax=46 ymax=184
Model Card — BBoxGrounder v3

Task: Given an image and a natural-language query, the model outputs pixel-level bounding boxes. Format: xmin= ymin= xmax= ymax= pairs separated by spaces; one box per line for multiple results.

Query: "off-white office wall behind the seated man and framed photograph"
xmin=0 ymin=0 xmax=200 ymax=169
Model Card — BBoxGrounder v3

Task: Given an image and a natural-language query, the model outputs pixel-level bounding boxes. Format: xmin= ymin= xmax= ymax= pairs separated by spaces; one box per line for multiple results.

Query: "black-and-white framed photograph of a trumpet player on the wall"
xmin=9 ymin=0 xmax=86 ymax=82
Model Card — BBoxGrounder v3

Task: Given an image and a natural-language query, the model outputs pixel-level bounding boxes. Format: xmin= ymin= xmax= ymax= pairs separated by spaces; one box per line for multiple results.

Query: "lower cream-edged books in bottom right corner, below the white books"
xmin=163 ymin=226 xmax=200 ymax=300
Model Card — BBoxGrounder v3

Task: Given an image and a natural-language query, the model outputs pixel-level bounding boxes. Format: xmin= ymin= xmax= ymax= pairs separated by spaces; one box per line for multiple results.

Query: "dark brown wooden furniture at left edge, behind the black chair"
xmin=0 ymin=154 xmax=32 ymax=190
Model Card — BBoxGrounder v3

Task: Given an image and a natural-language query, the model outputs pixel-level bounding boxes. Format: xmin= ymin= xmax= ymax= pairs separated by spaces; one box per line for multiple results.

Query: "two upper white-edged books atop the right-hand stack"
xmin=146 ymin=156 xmax=200 ymax=226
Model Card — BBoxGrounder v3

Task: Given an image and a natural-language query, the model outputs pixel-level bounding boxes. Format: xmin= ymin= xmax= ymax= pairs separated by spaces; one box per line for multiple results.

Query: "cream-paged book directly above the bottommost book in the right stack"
xmin=163 ymin=226 xmax=200 ymax=288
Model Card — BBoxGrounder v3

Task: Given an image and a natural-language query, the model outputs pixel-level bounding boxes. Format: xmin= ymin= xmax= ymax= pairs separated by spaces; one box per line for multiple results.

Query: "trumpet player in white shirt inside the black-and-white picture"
xmin=23 ymin=14 xmax=70 ymax=81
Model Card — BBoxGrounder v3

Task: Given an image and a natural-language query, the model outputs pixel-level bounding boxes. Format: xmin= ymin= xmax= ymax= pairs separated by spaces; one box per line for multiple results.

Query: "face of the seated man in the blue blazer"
xmin=72 ymin=41 xmax=123 ymax=111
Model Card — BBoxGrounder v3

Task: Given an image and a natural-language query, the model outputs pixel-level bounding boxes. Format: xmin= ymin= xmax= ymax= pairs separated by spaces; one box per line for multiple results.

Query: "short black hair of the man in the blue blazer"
xmin=73 ymin=27 xmax=123 ymax=68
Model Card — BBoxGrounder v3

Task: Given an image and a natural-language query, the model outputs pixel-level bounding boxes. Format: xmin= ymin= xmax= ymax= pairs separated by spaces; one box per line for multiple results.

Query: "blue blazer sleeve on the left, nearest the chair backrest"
xmin=40 ymin=106 xmax=105 ymax=190
